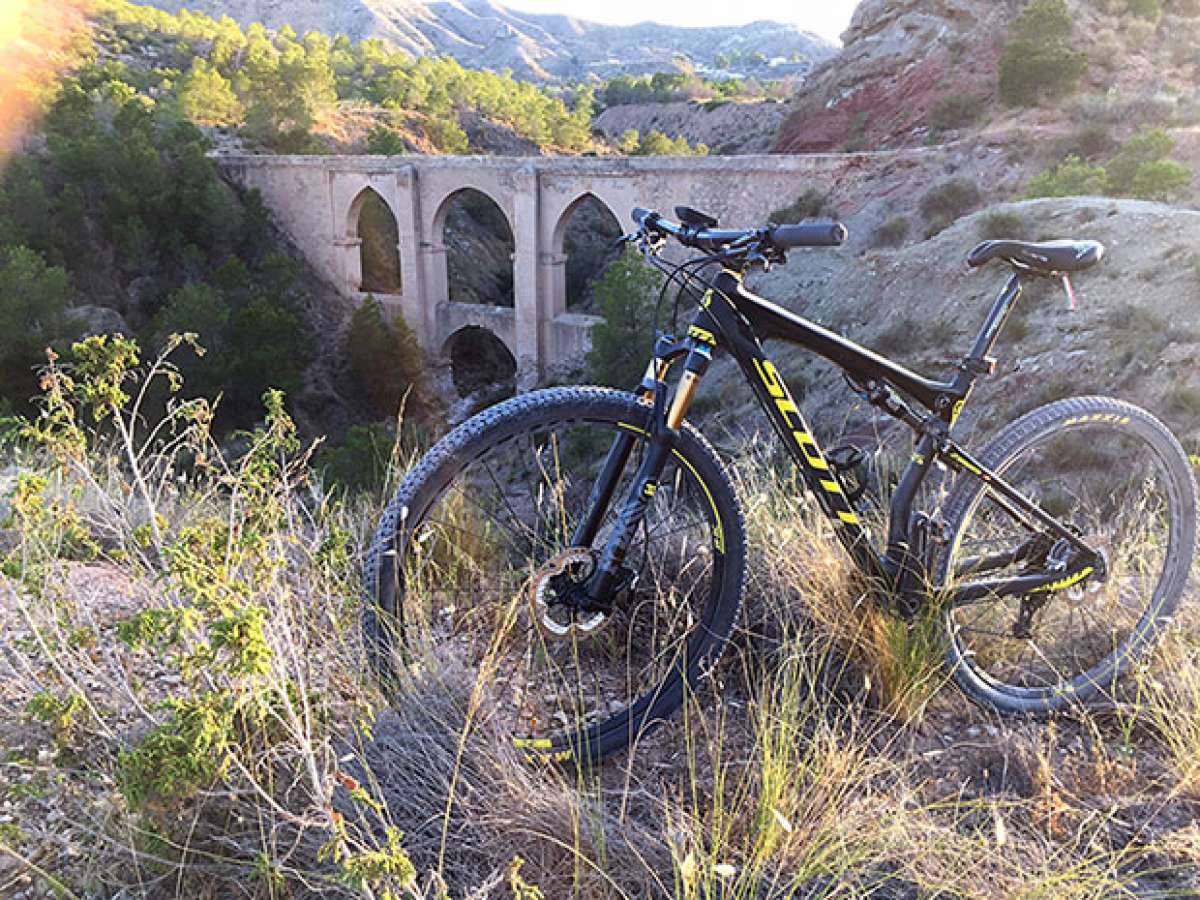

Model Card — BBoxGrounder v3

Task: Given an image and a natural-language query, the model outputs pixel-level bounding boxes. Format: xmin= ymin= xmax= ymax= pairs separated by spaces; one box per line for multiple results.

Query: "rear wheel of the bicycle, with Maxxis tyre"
xmin=940 ymin=397 xmax=1196 ymax=713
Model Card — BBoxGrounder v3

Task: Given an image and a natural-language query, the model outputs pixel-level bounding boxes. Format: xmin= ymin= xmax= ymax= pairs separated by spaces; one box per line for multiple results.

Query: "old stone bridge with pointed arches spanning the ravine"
xmin=215 ymin=154 xmax=907 ymax=386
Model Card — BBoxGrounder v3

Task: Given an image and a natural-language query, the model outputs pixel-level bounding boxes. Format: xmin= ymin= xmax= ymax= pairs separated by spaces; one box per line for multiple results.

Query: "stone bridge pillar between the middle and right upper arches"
xmin=512 ymin=166 xmax=544 ymax=390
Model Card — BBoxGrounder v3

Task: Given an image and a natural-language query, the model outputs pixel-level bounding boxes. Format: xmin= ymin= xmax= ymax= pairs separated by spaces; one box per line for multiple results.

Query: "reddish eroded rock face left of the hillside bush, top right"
xmin=775 ymin=0 xmax=1013 ymax=152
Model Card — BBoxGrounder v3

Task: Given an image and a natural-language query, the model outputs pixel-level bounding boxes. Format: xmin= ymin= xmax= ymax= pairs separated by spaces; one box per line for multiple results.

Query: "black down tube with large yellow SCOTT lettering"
xmin=737 ymin=346 xmax=884 ymax=576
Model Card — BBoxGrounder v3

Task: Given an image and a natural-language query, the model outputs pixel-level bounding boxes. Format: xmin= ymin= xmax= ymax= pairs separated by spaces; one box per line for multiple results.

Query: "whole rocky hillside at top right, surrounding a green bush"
xmin=775 ymin=0 xmax=1200 ymax=152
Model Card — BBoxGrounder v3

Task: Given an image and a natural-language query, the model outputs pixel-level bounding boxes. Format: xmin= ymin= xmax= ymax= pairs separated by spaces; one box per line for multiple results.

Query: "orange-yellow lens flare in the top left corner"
xmin=0 ymin=0 xmax=88 ymax=158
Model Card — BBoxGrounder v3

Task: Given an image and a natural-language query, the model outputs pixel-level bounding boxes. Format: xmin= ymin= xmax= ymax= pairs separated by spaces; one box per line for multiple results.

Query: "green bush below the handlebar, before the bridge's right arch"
xmin=587 ymin=251 xmax=660 ymax=388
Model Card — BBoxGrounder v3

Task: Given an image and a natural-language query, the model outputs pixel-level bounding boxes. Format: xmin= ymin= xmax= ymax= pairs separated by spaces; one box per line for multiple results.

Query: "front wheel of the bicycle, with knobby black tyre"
xmin=364 ymin=388 xmax=745 ymax=762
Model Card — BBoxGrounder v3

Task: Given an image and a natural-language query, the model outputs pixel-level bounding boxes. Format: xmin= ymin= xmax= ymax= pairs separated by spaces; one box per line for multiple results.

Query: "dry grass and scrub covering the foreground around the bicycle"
xmin=0 ymin=340 xmax=1200 ymax=900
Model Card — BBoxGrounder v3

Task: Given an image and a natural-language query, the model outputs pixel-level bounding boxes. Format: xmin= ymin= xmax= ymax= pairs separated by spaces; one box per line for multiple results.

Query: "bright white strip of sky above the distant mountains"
xmin=504 ymin=0 xmax=858 ymax=43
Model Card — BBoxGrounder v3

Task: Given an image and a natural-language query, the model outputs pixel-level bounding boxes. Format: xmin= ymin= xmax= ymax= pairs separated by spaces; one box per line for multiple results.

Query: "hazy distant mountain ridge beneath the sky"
xmin=126 ymin=0 xmax=838 ymax=80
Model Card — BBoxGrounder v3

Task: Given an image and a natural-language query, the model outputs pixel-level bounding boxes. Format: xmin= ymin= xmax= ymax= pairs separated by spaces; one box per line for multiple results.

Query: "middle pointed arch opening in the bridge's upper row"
xmin=434 ymin=187 xmax=516 ymax=307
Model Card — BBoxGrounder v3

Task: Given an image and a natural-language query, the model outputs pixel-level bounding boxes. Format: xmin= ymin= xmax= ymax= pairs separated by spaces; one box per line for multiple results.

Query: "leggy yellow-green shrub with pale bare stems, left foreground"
xmin=4 ymin=336 xmax=424 ymax=895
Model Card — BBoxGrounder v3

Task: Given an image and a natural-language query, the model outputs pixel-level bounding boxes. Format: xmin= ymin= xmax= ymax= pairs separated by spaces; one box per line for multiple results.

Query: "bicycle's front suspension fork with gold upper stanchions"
xmin=572 ymin=338 xmax=713 ymax=610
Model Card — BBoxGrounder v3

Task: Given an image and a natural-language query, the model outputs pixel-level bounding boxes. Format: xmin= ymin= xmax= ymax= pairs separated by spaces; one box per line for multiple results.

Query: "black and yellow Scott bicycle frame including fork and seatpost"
xmin=575 ymin=269 xmax=1103 ymax=612
